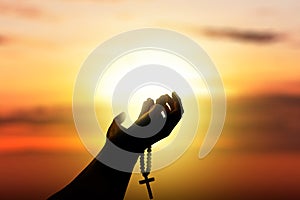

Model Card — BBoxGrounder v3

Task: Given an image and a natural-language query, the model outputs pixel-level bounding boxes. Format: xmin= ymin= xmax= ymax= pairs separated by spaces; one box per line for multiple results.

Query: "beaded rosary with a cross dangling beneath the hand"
xmin=139 ymin=146 xmax=154 ymax=199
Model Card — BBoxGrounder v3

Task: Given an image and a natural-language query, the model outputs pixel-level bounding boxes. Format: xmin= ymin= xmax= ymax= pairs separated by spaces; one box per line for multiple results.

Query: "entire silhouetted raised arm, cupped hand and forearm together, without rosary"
xmin=49 ymin=92 xmax=183 ymax=200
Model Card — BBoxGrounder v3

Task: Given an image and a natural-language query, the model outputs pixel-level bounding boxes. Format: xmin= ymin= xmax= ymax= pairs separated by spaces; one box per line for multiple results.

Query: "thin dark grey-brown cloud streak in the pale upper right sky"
xmin=201 ymin=28 xmax=284 ymax=43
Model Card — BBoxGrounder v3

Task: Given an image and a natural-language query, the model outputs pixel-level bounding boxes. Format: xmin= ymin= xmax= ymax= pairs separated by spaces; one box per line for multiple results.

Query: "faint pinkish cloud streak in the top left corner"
xmin=0 ymin=1 xmax=42 ymax=18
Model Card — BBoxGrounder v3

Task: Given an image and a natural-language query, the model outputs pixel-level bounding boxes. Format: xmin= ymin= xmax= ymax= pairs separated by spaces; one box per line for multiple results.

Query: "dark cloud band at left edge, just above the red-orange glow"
xmin=0 ymin=107 xmax=72 ymax=126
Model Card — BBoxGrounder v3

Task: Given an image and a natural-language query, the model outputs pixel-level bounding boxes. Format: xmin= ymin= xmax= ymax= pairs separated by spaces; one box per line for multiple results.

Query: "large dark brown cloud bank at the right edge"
xmin=221 ymin=95 xmax=300 ymax=152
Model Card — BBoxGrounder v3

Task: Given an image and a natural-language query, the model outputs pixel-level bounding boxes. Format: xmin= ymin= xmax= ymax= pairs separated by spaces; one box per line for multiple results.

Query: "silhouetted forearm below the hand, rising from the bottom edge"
xmin=50 ymin=142 xmax=138 ymax=200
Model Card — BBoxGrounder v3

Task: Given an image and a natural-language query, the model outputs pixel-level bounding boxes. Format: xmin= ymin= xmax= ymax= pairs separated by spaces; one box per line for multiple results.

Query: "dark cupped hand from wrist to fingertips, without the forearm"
xmin=107 ymin=92 xmax=184 ymax=152
